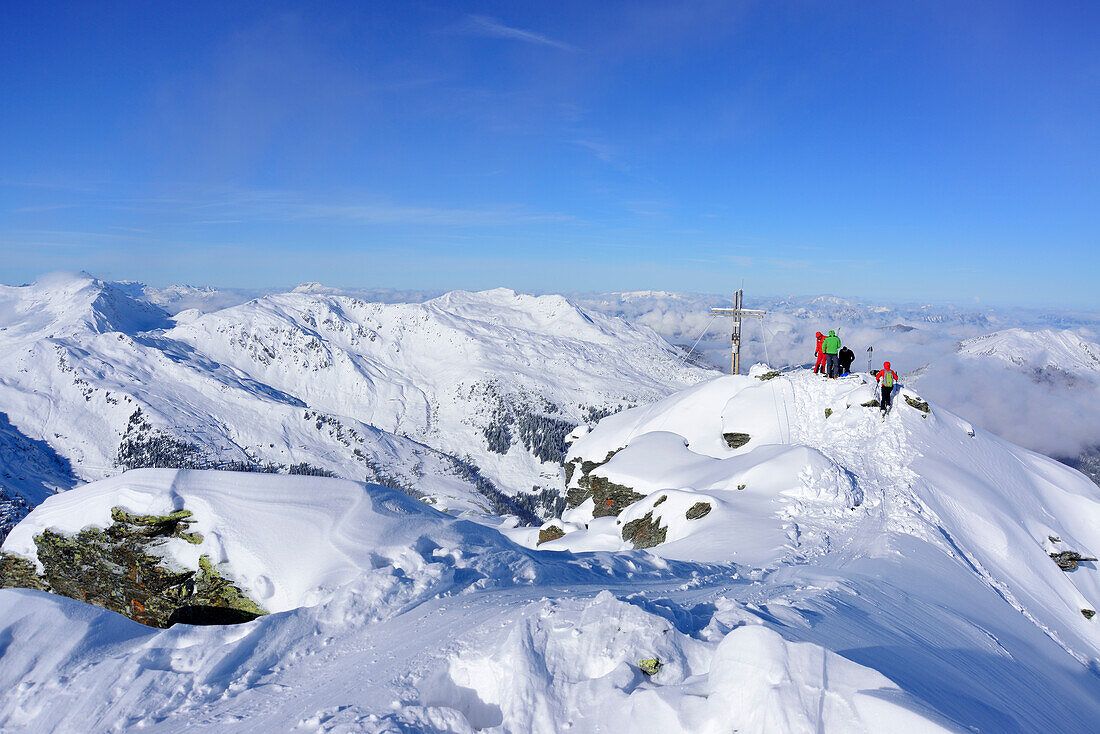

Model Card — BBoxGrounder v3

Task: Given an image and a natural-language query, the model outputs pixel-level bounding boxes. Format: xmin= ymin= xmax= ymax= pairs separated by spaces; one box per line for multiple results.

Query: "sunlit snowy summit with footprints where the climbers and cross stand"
xmin=539 ymin=370 xmax=1100 ymax=660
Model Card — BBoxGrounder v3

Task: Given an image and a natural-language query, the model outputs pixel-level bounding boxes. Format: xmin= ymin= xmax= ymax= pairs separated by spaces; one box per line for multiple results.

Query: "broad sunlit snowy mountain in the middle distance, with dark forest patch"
xmin=165 ymin=289 xmax=705 ymax=499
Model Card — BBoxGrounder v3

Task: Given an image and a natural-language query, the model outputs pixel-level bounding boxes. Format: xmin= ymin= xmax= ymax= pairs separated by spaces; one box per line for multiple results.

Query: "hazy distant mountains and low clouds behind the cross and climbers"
xmin=574 ymin=292 xmax=1100 ymax=482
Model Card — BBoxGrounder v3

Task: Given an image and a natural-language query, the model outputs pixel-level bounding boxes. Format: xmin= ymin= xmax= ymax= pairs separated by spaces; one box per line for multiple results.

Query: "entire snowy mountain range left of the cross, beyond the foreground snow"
xmin=0 ymin=274 xmax=707 ymax=530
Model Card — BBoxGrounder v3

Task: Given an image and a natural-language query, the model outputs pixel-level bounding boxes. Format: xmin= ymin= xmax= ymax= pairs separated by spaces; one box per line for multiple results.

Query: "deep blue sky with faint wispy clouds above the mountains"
xmin=0 ymin=0 xmax=1100 ymax=307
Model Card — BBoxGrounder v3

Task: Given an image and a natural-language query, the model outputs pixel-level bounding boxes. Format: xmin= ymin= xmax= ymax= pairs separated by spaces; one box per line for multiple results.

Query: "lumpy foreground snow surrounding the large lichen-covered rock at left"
xmin=0 ymin=470 xmax=958 ymax=734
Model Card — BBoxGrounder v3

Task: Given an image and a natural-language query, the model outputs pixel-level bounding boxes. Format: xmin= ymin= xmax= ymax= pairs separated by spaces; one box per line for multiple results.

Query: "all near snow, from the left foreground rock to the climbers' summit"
xmin=0 ymin=370 xmax=1100 ymax=734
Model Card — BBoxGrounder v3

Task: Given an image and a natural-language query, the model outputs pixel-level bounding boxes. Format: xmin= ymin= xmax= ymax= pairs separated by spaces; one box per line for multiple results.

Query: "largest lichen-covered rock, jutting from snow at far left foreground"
xmin=0 ymin=507 xmax=266 ymax=627
